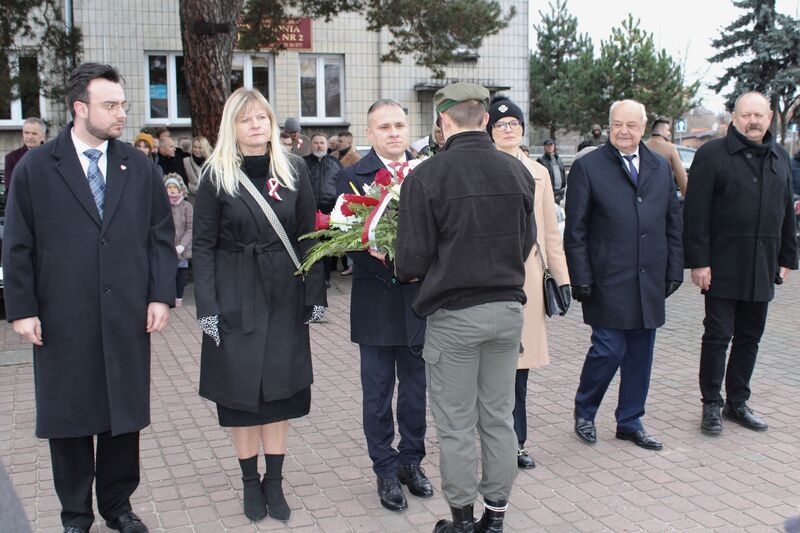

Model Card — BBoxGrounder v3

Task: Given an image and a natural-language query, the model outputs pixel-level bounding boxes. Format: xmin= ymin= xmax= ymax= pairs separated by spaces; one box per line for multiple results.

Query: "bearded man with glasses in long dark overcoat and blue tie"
xmin=3 ymin=63 xmax=176 ymax=533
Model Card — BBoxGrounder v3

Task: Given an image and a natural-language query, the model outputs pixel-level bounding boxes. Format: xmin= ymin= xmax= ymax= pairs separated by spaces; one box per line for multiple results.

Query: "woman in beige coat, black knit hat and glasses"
xmin=487 ymin=97 xmax=569 ymax=468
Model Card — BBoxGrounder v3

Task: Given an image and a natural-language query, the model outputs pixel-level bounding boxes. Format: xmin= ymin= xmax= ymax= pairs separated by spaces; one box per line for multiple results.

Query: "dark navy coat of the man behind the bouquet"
xmin=336 ymin=150 xmax=425 ymax=346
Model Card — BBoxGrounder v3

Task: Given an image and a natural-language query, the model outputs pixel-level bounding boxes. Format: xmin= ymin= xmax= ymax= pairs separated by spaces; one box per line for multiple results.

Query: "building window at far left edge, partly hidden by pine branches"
xmin=0 ymin=55 xmax=44 ymax=126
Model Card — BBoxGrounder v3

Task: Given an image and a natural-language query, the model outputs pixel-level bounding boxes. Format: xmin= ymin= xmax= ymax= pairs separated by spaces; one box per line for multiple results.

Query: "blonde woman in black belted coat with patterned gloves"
xmin=193 ymin=88 xmax=326 ymax=521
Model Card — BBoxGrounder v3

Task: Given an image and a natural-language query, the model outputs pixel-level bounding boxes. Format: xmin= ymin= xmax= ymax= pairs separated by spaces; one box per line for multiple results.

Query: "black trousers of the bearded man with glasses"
xmin=50 ymin=431 xmax=139 ymax=529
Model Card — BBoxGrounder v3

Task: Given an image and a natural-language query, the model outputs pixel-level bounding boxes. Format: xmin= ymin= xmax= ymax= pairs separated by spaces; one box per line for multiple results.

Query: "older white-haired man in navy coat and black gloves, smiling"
xmin=564 ymin=100 xmax=683 ymax=450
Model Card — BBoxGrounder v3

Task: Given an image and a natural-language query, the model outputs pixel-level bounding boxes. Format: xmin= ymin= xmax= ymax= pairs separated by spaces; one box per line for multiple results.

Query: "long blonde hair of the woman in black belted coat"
xmin=200 ymin=87 xmax=297 ymax=196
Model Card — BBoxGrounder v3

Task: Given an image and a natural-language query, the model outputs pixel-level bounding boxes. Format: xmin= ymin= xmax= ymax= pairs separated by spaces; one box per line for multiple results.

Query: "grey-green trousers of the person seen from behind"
xmin=422 ymin=302 xmax=522 ymax=508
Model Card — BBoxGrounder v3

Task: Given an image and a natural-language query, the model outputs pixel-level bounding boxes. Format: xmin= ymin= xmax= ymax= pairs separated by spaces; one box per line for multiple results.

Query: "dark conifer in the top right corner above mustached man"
xmin=709 ymin=0 xmax=800 ymax=139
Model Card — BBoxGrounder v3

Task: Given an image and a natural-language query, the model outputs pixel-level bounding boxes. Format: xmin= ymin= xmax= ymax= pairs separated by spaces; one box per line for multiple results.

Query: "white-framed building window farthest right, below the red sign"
xmin=300 ymin=54 xmax=344 ymax=124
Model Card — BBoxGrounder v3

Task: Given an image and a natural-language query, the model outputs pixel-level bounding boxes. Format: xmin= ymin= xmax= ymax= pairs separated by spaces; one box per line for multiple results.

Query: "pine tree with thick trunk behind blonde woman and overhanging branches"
xmin=179 ymin=0 xmax=516 ymax=141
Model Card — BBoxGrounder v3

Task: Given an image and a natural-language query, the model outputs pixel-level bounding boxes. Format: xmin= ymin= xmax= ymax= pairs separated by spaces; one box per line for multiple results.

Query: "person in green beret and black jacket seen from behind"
xmin=395 ymin=83 xmax=536 ymax=533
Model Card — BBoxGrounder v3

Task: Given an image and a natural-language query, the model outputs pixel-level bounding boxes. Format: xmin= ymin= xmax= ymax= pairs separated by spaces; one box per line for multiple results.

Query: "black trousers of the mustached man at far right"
xmin=700 ymin=295 xmax=769 ymax=404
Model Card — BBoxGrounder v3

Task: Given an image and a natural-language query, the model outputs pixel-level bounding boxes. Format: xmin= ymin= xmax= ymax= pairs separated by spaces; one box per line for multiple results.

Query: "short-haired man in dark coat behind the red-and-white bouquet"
xmin=337 ymin=99 xmax=433 ymax=511
